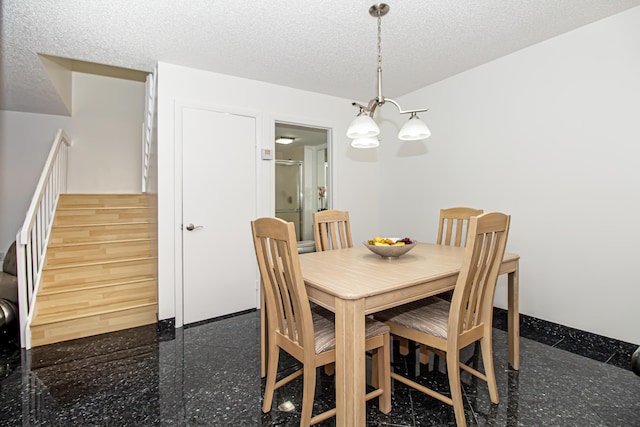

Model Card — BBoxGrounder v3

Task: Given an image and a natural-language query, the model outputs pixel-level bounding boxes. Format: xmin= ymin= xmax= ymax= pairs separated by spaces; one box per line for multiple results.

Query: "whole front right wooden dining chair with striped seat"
xmin=375 ymin=212 xmax=510 ymax=426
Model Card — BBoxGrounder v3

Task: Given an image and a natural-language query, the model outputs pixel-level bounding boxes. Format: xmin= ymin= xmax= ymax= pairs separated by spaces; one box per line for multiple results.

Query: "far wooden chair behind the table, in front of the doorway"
xmin=313 ymin=210 xmax=353 ymax=252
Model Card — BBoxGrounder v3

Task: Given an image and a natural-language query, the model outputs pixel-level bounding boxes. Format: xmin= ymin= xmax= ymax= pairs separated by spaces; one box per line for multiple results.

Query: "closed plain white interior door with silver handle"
xmin=182 ymin=107 xmax=257 ymax=324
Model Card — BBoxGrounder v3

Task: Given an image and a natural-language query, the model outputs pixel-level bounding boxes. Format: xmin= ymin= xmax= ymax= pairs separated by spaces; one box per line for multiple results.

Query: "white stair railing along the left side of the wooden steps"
xmin=16 ymin=129 xmax=71 ymax=349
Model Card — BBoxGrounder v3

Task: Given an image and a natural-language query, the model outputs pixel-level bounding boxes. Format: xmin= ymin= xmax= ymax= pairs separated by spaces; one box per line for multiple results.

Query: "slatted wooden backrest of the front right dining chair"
xmin=449 ymin=212 xmax=510 ymax=338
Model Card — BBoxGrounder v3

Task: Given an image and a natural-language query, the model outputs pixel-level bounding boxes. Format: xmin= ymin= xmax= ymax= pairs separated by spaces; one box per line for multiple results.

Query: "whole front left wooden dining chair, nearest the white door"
xmin=251 ymin=218 xmax=391 ymax=426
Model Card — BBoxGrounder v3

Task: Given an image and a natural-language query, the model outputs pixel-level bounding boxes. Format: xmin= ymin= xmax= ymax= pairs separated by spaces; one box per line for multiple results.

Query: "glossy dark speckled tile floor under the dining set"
xmin=0 ymin=312 xmax=640 ymax=426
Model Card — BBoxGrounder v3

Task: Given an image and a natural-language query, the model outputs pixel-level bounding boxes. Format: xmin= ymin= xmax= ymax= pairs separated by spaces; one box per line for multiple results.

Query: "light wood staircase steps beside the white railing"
xmin=31 ymin=194 xmax=158 ymax=347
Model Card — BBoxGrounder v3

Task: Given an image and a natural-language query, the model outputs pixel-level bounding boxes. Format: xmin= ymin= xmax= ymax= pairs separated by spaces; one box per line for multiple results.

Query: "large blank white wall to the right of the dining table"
xmin=380 ymin=7 xmax=640 ymax=343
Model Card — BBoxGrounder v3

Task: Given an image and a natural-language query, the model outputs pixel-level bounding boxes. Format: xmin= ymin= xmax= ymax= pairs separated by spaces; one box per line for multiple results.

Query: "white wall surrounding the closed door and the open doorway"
xmin=158 ymin=63 xmax=380 ymax=320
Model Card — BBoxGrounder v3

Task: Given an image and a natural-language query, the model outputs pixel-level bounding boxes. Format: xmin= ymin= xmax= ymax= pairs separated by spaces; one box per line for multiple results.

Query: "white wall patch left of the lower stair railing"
xmin=0 ymin=110 xmax=71 ymax=252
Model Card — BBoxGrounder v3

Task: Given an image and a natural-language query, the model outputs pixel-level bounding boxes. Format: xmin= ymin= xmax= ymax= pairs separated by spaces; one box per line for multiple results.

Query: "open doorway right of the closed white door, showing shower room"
xmin=275 ymin=122 xmax=331 ymax=252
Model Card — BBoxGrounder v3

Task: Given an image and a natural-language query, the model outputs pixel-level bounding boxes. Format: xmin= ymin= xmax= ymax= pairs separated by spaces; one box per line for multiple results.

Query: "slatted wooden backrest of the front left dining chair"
xmin=251 ymin=217 xmax=315 ymax=348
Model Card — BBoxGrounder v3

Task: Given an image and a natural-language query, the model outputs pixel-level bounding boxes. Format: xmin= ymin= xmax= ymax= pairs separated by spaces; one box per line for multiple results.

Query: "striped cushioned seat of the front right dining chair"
xmin=375 ymin=297 xmax=451 ymax=340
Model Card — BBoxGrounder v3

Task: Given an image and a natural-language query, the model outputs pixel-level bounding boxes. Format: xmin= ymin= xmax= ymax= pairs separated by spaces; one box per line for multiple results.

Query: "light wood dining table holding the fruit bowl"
xmin=300 ymin=243 xmax=520 ymax=427
